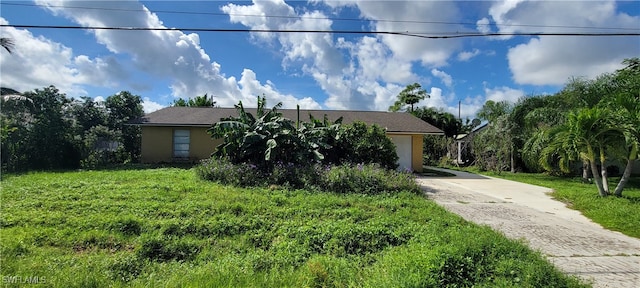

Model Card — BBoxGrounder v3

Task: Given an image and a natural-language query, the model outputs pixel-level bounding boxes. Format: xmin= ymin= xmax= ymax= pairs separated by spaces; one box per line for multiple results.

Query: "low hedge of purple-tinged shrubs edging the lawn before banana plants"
xmin=195 ymin=157 xmax=420 ymax=195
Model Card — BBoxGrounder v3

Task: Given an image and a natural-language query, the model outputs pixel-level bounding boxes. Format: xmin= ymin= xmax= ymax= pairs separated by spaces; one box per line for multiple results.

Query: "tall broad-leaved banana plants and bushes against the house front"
xmin=209 ymin=97 xmax=398 ymax=173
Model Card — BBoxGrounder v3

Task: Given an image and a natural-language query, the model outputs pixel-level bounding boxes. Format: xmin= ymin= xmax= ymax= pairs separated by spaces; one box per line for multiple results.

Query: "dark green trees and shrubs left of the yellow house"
xmin=0 ymin=86 xmax=143 ymax=171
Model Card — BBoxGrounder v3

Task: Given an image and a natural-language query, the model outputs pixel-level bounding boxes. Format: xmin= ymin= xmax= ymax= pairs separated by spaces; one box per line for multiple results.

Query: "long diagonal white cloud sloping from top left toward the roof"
xmin=30 ymin=0 xmax=319 ymax=109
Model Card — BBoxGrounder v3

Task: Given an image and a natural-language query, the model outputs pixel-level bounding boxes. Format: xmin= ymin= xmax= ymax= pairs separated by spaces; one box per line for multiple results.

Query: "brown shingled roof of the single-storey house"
xmin=130 ymin=107 xmax=443 ymax=134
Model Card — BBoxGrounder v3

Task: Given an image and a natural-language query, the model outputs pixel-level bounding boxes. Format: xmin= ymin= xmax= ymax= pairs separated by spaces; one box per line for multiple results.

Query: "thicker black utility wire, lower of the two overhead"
xmin=0 ymin=24 xmax=640 ymax=39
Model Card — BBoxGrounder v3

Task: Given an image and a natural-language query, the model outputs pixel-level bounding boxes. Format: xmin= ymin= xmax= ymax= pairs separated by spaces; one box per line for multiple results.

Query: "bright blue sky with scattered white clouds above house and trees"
xmin=0 ymin=0 xmax=640 ymax=118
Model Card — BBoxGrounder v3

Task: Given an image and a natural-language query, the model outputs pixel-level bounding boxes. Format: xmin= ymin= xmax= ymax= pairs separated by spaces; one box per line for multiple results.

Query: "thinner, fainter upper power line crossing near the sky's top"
xmin=0 ymin=2 xmax=640 ymax=31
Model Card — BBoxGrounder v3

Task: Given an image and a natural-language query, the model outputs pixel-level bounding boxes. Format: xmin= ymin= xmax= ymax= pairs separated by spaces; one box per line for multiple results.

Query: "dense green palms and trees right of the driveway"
xmin=474 ymin=58 xmax=640 ymax=196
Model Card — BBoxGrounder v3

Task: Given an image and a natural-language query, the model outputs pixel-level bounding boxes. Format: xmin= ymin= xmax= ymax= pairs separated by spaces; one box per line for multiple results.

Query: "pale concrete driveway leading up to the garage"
xmin=417 ymin=170 xmax=640 ymax=288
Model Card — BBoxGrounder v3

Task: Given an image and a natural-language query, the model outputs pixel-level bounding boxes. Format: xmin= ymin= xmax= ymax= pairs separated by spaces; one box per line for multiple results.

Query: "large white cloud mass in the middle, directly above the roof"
xmin=221 ymin=0 xmax=459 ymax=110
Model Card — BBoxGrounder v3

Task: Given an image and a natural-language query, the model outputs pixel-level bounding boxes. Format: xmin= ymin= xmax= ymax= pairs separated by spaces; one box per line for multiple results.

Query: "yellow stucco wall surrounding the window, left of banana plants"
xmin=141 ymin=126 xmax=222 ymax=163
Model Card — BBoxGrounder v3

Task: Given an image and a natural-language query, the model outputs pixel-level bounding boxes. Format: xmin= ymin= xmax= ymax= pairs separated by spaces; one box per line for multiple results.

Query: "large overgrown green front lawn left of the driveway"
xmin=0 ymin=168 xmax=586 ymax=287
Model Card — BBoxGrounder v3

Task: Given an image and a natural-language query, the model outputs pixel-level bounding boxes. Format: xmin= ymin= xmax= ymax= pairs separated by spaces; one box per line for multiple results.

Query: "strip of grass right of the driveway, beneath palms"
xmin=458 ymin=169 xmax=640 ymax=238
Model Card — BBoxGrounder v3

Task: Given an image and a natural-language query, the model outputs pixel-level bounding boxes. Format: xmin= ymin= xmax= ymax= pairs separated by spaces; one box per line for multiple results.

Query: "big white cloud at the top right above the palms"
xmin=482 ymin=0 xmax=640 ymax=85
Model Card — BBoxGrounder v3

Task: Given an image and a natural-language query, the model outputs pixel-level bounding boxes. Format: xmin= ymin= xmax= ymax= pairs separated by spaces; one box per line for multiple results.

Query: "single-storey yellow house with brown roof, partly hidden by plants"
xmin=131 ymin=107 xmax=443 ymax=171
